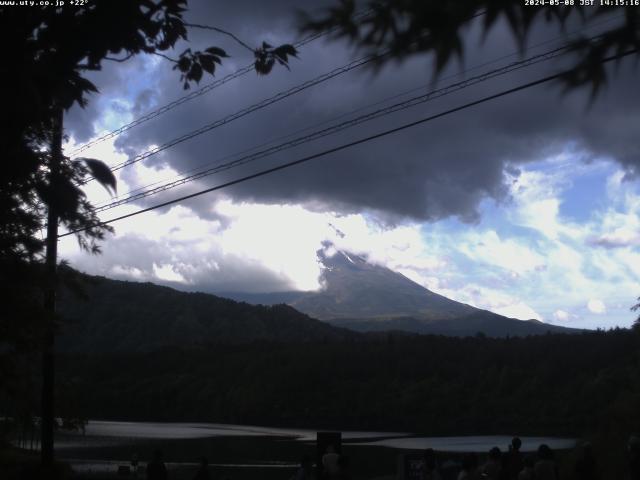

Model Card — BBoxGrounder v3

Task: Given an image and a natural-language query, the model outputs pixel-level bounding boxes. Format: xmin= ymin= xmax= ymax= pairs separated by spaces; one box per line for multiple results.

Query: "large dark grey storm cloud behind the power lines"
xmin=66 ymin=1 xmax=640 ymax=221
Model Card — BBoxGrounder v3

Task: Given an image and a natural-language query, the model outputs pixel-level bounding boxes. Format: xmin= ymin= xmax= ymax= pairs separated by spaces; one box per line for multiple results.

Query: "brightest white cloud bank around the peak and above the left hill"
xmin=60 ymin=195 xmax=439 ymax=291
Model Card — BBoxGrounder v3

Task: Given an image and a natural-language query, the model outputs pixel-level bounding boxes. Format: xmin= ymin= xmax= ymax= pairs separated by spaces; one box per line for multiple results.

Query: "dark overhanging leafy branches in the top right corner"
xmin=301 ymin=0 xmax=640 ymax=94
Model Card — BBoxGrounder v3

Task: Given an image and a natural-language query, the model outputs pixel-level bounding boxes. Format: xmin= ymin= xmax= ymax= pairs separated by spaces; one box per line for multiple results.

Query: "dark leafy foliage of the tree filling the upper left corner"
xmin=0 ymin=0 xmax=296 ymax=268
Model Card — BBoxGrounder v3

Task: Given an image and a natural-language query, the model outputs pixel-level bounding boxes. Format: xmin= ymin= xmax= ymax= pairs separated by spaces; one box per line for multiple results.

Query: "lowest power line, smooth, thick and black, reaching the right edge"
xmin=59 ymin=49 xmax=638 ymax=238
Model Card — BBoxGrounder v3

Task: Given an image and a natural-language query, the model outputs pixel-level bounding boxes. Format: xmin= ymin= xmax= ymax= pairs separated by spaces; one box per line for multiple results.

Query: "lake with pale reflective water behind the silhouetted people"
xmin=56 ymin=420 xmax=575 ymax=479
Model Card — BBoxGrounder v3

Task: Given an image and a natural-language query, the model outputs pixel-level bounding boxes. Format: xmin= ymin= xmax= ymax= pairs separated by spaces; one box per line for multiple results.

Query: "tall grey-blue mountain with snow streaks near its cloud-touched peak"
xmin=221 ymin=250 xmax=579 ymax=337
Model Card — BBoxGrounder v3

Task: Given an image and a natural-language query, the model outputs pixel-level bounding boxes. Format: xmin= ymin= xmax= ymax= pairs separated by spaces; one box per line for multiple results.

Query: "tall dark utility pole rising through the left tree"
xmin=41 ymin=107 xmax=63 ymax=474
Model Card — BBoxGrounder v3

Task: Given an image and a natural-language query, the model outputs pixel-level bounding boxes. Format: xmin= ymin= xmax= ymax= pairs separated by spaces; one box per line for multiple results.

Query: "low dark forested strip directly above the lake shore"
xmin=55 ymin=330 xmax=640 ymax=435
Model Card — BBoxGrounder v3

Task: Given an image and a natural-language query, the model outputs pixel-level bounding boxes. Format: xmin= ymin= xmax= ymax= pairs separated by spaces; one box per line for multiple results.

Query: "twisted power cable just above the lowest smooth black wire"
xmin=95 ymin=42 xmax=568 ymax=212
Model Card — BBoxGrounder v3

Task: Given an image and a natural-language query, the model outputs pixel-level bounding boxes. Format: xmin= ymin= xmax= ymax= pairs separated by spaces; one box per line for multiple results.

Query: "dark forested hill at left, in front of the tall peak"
xmin=57 ymin=274 xmax=357 ymax=352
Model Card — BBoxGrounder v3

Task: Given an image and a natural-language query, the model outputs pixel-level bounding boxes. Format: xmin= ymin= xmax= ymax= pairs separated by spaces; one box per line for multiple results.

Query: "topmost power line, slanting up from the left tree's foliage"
xmin=70 ymin=9 xmax=372 ymax=158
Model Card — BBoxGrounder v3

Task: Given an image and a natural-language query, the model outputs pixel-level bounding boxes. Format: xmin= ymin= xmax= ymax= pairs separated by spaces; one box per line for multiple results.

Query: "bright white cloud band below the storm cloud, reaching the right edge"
xmin=60 ymin=142 xmax=640 ymax=326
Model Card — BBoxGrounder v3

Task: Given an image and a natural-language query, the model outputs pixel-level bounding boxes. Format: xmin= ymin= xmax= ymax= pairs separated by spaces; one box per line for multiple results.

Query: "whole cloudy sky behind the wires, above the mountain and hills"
xmin=60 ymin=0 xmax=640 ymax=328
